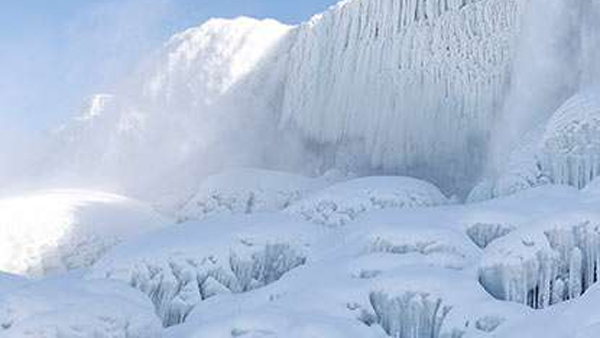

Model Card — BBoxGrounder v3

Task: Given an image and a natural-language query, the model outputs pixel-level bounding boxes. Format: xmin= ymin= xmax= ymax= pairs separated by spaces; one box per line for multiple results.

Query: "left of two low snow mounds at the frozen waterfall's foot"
xmin=180 ymin=169 xmax=324 ymax=220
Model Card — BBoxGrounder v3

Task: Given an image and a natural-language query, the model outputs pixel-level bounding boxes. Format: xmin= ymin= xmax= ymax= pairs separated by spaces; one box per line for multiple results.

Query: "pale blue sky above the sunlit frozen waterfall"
xmin=0 ymin=0 xmax=337 ymax=132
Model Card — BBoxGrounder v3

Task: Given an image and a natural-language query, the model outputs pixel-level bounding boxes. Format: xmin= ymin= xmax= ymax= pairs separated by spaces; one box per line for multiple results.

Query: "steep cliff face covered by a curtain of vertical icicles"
xmin=281 ymin=0 xmax=520 ymax=193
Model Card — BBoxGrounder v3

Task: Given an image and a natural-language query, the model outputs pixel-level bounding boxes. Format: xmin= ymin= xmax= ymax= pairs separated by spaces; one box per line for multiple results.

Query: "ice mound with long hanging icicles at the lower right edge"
xmin=479 ymin=213 xmax=600 ymax=308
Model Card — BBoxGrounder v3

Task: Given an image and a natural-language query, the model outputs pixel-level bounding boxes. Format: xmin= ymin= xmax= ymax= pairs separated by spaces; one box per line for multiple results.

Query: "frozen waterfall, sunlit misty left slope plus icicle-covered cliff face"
xmin=48 ymin=0 xmax=536 ymax=202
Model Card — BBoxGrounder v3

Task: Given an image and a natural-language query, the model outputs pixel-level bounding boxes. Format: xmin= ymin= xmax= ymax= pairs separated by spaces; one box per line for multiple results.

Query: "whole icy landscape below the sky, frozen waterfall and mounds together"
xmin=0 ymin=0 xmax=600 ymax=338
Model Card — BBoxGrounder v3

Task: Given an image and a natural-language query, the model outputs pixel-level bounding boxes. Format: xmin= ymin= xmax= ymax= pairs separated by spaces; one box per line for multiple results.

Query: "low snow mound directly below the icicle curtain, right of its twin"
xmin=288 ymin=176 xmax=448 ymax=226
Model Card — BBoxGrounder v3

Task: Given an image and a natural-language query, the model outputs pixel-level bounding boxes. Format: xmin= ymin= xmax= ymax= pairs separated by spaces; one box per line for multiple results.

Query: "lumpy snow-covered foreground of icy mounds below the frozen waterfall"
xmin=0 ymin=170 xmax=600 ymax=338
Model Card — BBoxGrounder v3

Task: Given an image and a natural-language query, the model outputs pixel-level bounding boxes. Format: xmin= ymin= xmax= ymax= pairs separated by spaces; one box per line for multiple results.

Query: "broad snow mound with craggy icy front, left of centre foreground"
xmin=91 ymin=214 xmax=313 ymax=326
